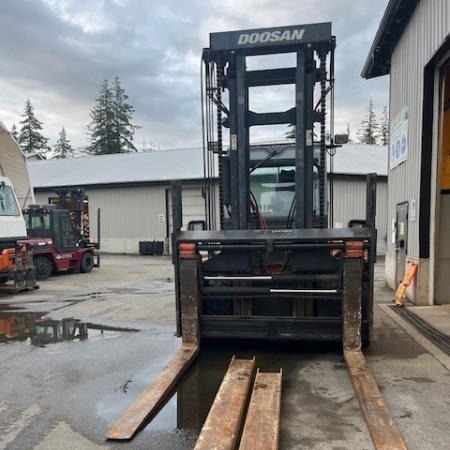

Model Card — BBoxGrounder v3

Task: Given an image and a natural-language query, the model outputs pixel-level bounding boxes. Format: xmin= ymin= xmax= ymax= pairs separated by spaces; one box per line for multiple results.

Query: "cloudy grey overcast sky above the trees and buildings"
xmin=0 ymin=0 xmax=388 ymax=149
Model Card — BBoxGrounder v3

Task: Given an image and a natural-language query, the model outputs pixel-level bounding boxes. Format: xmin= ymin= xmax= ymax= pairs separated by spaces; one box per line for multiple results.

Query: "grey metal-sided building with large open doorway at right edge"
xmin=362 ymin=0 xmax=450 ymax=305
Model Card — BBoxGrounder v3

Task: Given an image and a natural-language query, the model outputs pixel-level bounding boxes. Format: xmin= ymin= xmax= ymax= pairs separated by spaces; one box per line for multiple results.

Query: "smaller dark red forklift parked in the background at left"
xmin=23 ymin=189 xmax=100 ymax=280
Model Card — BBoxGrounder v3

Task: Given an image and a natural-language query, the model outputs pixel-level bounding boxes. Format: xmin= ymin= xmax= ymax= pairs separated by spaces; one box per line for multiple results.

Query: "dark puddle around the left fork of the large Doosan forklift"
xmin=97 ymin=343 xmax=336 ymax=450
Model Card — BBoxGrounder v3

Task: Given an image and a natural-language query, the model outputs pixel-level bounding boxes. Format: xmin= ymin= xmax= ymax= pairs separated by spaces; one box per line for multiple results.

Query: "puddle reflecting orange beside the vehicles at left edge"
xmin=0 ymin=312 xmax=139 ymax=347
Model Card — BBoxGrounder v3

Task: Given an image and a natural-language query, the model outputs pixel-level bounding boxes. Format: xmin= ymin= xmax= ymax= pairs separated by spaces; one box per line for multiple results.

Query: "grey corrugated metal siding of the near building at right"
xmin=387 ymin=0 xmax=450 ymax=257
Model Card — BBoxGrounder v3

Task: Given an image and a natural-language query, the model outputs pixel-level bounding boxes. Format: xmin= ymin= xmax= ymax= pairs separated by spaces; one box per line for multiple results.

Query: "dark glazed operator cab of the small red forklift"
xmin=24 ymin=205 xmax=80 ymax=252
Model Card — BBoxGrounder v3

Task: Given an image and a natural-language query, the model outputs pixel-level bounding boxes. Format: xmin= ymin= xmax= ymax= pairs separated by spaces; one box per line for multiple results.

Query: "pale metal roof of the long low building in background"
xmin=28 ymin=144 xmax=387 ymax=188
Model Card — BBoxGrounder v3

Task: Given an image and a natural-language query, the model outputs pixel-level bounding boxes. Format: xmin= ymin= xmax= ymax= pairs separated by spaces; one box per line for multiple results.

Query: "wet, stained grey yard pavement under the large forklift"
xmin=0 ymin=255 xmax=450 ymax=450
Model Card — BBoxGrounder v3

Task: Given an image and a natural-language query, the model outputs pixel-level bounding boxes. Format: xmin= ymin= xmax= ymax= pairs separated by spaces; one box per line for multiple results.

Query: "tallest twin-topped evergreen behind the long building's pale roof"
xmin=88 ymin=77 xmax=136 ymax=155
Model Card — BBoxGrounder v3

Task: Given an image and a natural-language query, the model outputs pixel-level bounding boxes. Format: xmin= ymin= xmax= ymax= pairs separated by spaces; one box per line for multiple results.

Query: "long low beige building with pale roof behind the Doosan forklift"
xmin=28 ymin=144 xmax=387 ymax=254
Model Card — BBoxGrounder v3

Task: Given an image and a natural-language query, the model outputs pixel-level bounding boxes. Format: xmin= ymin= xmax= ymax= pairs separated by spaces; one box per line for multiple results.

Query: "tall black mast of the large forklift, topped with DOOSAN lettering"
xmin=203 ymin=23 xmax=335 ymax=230
